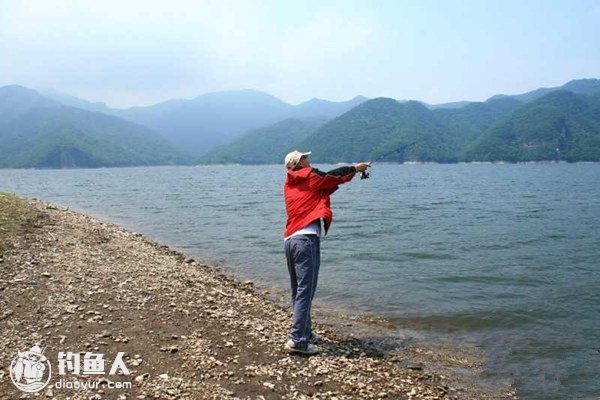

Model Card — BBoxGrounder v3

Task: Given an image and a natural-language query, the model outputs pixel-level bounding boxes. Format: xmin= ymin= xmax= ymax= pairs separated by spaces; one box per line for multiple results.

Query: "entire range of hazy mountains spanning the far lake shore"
xmin=0 ymin=79 xmax=600 ymax=168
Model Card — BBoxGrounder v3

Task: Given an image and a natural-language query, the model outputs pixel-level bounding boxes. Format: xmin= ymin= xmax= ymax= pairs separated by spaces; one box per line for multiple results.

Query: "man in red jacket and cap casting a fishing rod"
xmin=284 ymin=150 xmax=369 ymax=354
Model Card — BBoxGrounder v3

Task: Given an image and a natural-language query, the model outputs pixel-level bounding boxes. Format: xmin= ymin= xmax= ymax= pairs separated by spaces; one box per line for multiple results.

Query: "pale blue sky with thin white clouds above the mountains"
xmin=0 ymin=0 xmax=600 ymax=108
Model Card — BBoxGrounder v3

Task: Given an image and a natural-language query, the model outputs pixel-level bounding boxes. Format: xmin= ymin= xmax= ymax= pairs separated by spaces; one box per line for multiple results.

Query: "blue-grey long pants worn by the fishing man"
xmin=284 ymin=235 xmax=321 ymax=347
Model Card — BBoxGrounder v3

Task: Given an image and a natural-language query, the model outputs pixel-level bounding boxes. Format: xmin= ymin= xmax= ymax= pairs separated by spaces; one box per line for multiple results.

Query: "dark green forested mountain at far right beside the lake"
xmin=465 ymin=90 xmax=600 ymax=162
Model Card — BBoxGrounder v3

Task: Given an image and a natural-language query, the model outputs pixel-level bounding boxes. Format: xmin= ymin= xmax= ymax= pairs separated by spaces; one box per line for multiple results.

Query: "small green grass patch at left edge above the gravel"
xmin=0 ymin=192 xmax=40 ymax=257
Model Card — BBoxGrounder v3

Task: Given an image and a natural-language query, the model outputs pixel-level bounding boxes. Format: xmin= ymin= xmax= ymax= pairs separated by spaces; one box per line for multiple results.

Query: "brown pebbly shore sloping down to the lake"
xmin=0 ymin=193 xmax=516 ymax=399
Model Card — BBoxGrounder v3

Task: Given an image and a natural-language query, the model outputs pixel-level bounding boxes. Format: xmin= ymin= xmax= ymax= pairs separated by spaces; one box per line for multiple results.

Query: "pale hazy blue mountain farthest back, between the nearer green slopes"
xmin=38 ymin=90 xmax=367 ymax=155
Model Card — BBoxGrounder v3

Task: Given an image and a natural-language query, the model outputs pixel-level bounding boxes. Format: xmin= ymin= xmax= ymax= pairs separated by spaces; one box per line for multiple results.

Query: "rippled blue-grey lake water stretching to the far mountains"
xmin=0 ymin=163 xmax=600 ymax=399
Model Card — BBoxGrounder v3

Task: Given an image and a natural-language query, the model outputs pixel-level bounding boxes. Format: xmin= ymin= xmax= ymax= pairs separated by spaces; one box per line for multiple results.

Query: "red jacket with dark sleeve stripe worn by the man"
xmin=283 ymin=167 xmax=356 ymax=237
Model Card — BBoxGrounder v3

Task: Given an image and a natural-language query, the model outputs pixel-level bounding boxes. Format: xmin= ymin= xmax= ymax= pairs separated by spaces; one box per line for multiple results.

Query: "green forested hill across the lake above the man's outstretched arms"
xmin=300 ymin=98 xmax=521 ymax=162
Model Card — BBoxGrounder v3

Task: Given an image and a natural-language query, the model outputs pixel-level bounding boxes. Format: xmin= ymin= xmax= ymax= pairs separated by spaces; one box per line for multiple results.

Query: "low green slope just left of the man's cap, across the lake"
xmin=200 ymin=118 xmax=327 ymax=164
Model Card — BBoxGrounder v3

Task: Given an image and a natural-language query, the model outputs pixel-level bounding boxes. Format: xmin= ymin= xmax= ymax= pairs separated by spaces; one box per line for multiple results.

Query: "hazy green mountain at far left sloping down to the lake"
xmin=0 ymin=86 xmax=189 ymax=168
